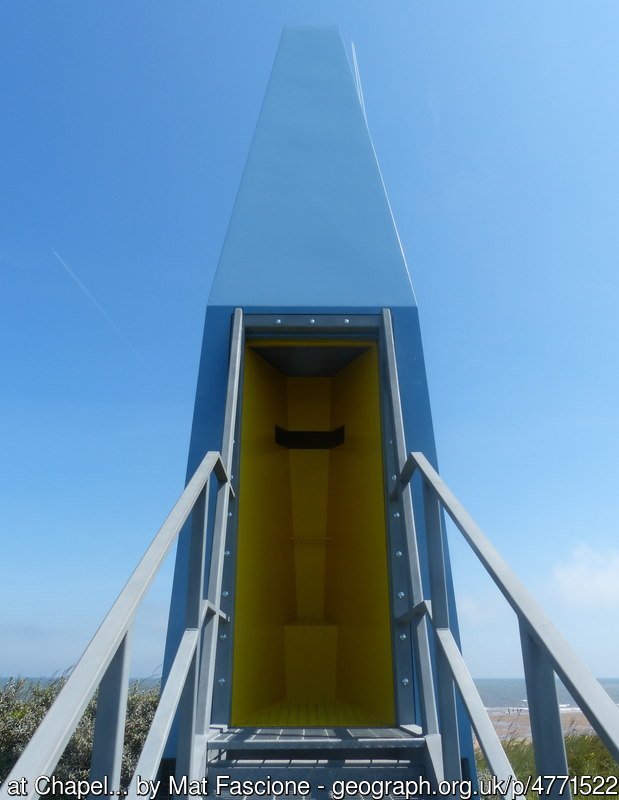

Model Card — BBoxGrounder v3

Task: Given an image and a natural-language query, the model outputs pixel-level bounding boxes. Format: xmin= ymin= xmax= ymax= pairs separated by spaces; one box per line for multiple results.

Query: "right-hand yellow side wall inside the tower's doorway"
xmin=327 ymin=347 xmax=394 ymax=725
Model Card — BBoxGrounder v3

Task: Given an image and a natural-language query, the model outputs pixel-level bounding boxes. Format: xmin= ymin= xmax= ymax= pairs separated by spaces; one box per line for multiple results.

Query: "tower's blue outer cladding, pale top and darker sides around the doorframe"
xmin=164 ymin=28 xmax=473 ymax=776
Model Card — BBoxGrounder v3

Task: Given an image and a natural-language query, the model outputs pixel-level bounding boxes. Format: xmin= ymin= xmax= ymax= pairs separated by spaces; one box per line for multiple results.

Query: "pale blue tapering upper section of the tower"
xmin=209 ymin=28 xmax=415 ymax=310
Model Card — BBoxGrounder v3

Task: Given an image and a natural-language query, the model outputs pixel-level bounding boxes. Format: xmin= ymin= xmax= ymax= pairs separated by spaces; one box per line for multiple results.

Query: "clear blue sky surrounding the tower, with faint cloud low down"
xmin=0 ymin=0 xmax=619 ymax=676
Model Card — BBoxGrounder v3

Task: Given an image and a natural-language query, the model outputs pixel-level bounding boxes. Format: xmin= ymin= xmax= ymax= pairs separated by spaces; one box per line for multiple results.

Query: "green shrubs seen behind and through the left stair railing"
xmin=0 ymin=675 xmax=159 ymax=786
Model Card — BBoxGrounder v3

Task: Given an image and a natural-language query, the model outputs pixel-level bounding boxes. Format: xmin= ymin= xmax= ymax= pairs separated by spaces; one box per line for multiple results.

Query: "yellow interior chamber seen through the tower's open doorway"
xmin=231 ymin=340 xmax=394 ymax=726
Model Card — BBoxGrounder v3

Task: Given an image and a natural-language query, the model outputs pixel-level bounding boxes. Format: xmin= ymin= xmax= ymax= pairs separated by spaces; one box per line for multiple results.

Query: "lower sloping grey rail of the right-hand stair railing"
xmin=435 ymin=628 xmax=515 ymax=798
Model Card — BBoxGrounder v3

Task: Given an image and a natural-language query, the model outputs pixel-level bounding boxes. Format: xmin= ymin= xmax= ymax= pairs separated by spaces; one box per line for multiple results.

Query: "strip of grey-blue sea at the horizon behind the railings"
xmin=0 ymin=678 xmax=619 ymax=713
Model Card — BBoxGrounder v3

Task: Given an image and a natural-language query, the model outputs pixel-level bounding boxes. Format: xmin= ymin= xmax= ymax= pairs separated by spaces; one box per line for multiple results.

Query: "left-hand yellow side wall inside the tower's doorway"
xmin=232 ymin=349 xmax=295 ymax=724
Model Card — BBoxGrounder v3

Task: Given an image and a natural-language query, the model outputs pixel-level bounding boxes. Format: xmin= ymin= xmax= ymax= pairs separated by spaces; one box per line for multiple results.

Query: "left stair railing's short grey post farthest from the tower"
xmin=90 ymin=631 xmax=131 ymax=791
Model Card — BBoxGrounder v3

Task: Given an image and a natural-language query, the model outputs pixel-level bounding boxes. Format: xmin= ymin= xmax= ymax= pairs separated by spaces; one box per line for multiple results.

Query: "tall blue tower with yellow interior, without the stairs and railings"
xmin=164 ymin=28 xmax=473 ymax=788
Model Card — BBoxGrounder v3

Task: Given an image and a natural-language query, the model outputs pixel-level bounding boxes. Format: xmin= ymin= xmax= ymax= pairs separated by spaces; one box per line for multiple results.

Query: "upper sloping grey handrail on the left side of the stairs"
xmin=0 ymin=452 xmax=230 ymax=800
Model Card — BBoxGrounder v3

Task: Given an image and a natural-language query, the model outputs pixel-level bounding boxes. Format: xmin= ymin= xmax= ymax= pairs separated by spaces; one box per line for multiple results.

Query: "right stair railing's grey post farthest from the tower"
xmin=519 ymin=617 xmax=570 ymax=798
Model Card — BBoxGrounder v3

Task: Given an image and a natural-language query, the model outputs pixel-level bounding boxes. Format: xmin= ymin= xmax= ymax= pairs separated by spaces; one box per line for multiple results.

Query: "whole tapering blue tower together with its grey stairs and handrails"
xmin=0 ymin=23 xmax=619 ymax=800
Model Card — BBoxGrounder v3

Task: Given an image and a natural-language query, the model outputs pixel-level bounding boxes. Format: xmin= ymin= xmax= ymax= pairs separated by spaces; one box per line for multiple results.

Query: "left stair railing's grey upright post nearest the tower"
xmin=176 ymin=479 xmax=210 ymax=778
